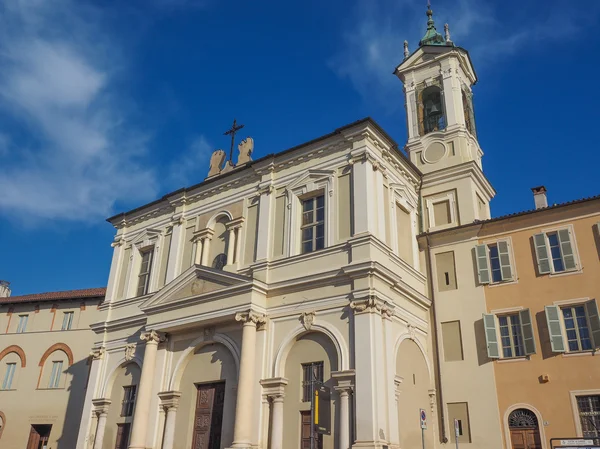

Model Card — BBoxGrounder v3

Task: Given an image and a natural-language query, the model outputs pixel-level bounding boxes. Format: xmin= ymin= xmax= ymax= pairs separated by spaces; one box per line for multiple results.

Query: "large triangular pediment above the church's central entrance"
xmin=141 ymin=265 xmax=252 ymax=310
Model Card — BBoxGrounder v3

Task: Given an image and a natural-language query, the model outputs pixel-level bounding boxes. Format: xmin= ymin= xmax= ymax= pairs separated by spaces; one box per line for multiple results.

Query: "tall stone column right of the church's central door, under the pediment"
xmin=232 ymin=310 xmax=266 ymax=448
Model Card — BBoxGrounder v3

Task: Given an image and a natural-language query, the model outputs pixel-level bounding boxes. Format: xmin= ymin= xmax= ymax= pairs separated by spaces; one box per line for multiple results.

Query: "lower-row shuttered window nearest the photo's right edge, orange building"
xmin=545 ymin=299 xmax=600 ymax=352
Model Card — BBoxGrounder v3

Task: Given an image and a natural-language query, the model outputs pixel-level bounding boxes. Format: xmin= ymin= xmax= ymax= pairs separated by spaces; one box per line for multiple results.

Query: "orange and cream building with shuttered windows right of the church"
xmin=421 ymin=187 xmax=600 ymax=449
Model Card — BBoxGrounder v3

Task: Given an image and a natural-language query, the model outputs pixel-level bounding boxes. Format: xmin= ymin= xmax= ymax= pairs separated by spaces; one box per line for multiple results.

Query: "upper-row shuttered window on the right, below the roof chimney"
xmin=533 ymin=227 xmax=579 ymax=275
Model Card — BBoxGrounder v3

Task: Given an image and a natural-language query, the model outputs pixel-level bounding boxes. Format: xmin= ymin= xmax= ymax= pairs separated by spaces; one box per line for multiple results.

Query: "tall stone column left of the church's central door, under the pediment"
xmin=129 ymin=331 xmax=164 ymax=449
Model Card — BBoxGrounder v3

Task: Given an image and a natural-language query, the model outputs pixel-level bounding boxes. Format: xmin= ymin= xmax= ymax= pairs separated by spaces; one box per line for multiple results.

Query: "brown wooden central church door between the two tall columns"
xmin=192 ymin=382 xmax=225 ymax=449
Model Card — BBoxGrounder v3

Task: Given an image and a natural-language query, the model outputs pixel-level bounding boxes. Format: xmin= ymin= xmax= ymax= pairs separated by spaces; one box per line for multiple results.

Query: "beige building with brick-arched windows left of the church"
xmin=0 ymin=281 xmax=105 ymax=449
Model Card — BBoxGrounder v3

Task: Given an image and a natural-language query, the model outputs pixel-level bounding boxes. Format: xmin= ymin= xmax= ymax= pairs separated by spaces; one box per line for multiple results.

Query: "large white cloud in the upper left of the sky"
xmin=0 ymin=0 xmax=157 ymax=223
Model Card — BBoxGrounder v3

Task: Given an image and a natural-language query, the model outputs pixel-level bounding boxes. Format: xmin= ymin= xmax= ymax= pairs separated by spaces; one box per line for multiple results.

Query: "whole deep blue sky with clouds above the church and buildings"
xmin=0 ymin=0 xmax=600 ymax=294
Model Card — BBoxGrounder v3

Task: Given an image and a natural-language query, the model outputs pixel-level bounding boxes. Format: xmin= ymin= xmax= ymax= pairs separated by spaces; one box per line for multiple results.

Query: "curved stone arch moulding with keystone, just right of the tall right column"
xmin=273 ymin=323 xmax=350 ymax=377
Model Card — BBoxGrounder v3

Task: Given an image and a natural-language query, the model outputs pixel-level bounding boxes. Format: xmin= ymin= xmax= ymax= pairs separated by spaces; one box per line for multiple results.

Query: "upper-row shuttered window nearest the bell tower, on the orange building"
xmin=475 ymin=240 xmax=515 ymax=284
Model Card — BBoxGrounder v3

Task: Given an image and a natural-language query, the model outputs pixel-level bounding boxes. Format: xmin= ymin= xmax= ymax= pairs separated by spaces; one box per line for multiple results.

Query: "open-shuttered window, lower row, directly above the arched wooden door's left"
xmin=483 ymin=309 xmax=536 ymax=359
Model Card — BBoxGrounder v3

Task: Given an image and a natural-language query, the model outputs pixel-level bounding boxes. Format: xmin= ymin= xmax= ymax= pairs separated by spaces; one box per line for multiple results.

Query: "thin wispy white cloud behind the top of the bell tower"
xmin=330 ymin=0 xmax=600 ymax=111
